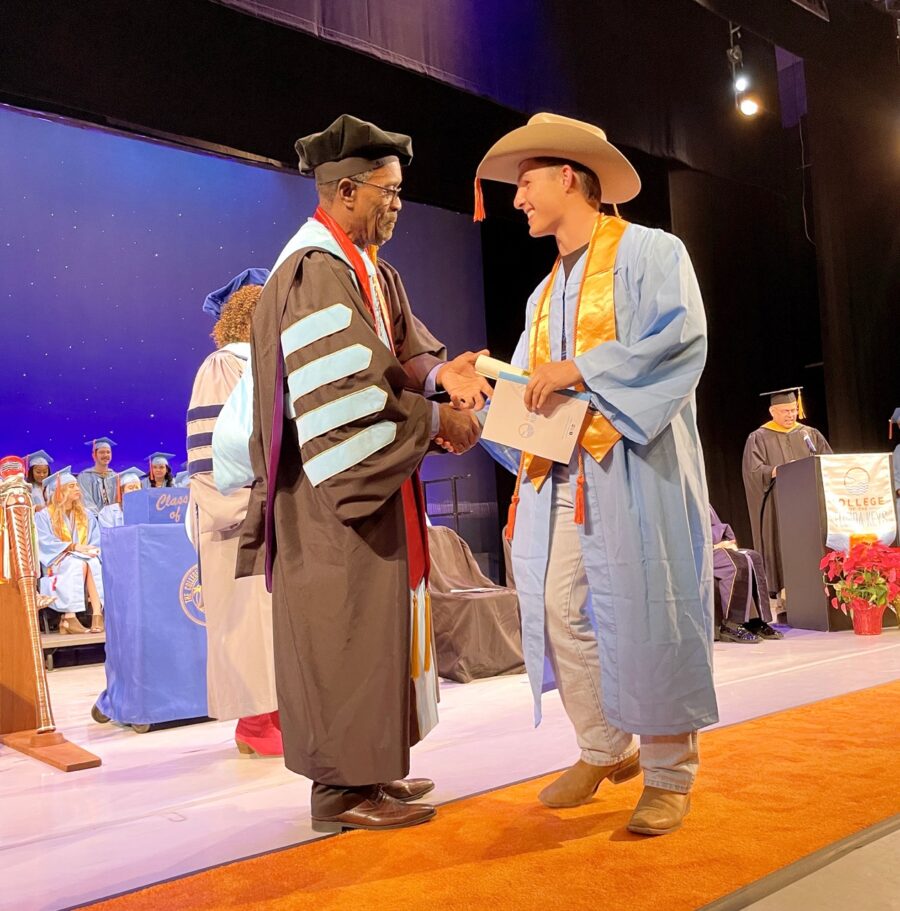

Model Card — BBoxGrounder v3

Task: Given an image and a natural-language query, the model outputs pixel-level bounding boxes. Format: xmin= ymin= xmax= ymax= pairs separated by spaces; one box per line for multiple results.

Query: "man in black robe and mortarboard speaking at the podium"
xmin=743 ymin=386 xmax=831 ymax=598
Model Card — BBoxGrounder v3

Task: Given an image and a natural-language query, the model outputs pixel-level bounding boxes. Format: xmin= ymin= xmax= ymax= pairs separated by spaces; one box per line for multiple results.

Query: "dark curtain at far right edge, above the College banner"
xmin=806 ymin=64 xmax=900 ymax=452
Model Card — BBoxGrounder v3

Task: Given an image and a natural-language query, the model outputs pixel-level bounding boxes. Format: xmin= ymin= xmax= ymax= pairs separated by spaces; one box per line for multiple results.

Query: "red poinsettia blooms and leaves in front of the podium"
xmin=819 ymin=541 xmax=900 ymax=617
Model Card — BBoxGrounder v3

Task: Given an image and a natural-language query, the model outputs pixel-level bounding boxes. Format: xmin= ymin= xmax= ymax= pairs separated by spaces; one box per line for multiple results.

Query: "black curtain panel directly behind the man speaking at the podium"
xmin=669 ymin=170 xmax=827 ymax=546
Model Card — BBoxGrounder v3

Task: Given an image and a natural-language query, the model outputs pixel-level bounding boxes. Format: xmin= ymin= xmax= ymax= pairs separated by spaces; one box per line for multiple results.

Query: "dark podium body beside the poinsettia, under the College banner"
xmin=774 ymin=455 xmax=897 ymax=632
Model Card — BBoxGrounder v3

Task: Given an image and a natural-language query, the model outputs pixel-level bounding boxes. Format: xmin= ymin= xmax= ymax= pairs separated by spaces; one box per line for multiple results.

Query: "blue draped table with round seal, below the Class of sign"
xmin=97 ymin=524 xmax=208 ymax=724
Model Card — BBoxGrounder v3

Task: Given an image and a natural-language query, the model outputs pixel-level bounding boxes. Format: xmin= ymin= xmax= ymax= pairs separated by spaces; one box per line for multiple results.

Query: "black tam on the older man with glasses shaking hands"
xmin=294 ymin=114 xmax=412 ymax=183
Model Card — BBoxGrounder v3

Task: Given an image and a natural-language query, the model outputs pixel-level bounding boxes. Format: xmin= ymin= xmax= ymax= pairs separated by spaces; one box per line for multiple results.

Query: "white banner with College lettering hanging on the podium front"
xmin=819 ymin=453 xmax=897 ymax=551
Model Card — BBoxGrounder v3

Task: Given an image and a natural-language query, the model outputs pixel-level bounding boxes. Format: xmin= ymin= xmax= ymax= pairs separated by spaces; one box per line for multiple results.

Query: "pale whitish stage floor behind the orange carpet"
xmin=0 ymin=630 xmax=900 ymax=911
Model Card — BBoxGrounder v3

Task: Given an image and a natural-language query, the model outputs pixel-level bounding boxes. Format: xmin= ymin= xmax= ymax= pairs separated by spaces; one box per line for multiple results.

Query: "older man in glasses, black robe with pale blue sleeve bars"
xmin=232 ymin=115 xmax=490 ymax=832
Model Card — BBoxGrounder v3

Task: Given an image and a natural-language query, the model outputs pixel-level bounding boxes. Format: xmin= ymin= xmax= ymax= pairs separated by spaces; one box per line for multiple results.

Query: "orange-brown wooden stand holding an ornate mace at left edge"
xmin=0 ymin=475 xmax=100 ymax=772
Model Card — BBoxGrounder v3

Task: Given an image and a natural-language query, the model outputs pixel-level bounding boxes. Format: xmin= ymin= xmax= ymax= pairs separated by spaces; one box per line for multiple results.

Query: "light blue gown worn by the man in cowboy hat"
xmin=485 ymin=225 xmax=718 ymax=734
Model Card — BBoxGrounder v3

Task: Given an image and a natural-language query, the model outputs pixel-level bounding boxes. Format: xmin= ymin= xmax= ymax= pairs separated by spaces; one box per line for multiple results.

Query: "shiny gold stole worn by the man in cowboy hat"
xmin=506 ymin=214 xmax=628 ymax=540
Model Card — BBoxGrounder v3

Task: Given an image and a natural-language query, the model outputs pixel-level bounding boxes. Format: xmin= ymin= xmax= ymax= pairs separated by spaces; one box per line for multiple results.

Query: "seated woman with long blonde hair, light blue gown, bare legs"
xmin=34 ymin=466 xmax=103 ymax=634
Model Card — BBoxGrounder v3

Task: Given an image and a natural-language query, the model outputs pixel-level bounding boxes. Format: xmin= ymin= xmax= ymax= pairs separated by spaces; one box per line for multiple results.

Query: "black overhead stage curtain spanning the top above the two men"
xmin=0 ymin=0 xmax=779 ymax=200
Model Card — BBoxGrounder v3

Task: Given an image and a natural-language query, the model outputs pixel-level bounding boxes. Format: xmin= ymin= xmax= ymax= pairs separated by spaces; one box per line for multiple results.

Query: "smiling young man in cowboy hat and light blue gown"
xmin=476 ymin=114 xmax=718 ymax=835
